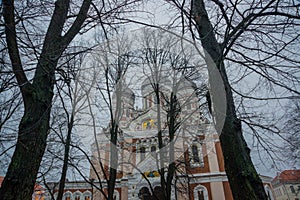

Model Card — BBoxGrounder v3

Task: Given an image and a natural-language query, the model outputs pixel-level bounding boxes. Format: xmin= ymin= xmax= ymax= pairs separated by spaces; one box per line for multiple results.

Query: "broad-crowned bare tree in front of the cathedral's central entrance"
xmin=103 ymin=29 xmax=209 ymax=199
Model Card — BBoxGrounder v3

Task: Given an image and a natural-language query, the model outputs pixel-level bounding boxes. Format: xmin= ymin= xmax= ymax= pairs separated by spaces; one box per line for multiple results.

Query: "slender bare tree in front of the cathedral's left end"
xmin=86 ymin=37 xmax=131 ymax=199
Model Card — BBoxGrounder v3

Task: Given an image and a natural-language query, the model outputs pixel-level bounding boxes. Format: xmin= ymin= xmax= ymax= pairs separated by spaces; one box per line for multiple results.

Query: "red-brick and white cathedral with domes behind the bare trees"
xmin=90 ymin=78 xmax=233 ymax=200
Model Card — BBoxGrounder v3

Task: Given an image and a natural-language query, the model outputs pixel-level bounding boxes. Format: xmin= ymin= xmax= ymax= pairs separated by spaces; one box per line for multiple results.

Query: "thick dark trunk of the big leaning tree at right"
xmin=193 ymin=0 xmax=267 ymax=200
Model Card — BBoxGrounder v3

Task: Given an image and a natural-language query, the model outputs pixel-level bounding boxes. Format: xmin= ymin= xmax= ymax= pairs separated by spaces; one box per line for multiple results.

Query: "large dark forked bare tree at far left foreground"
xmin=0 ymin=0 xmax=91 ymax=199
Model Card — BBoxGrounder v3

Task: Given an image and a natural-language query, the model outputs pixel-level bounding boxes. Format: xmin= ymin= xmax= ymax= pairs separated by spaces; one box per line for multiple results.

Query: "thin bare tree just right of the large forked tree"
xmin=56 ymin=48 xmax=95 ymax=200
